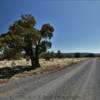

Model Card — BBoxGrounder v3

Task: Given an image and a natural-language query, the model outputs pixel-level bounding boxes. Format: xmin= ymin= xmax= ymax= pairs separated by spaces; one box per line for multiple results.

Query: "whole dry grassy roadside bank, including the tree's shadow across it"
xmin=0 ymin=58 xmax=86 ymax=84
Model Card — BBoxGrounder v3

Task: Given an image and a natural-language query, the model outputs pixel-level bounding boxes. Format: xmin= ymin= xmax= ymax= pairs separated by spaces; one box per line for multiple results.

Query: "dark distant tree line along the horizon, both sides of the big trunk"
xmin=0 ymin=49 xmax=97 ymax=60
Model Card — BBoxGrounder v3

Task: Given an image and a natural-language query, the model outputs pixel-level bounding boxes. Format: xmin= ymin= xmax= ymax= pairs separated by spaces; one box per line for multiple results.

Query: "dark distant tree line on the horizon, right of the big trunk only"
xmin=41 ymin=50 xmax=97 ymax=60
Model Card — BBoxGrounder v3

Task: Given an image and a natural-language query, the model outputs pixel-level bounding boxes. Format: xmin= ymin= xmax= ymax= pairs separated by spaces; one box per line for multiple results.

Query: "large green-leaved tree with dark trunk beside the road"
xmin=0 ymin=14 xmax=54 ymax=67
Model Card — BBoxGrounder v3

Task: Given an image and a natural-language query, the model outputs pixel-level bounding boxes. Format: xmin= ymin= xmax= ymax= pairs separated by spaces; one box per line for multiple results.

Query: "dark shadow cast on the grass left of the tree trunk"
xmin=0 ymin=66 xmax=33 ymax=79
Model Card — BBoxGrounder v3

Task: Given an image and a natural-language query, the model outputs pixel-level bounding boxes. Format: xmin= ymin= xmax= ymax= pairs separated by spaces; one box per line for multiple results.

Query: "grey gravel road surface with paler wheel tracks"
xmin=0 ymin=59 xmax=100 ymax=100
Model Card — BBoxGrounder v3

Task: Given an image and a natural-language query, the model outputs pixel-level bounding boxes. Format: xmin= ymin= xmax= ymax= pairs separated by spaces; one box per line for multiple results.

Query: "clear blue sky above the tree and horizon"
xmin=0 ymin=0 xmax=100 ymax=52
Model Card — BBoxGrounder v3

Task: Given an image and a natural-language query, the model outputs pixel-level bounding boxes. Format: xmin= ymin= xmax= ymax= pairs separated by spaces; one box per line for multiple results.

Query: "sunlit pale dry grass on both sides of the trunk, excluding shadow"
xmin=0 ymin=58 xmax=86 ymax=79
